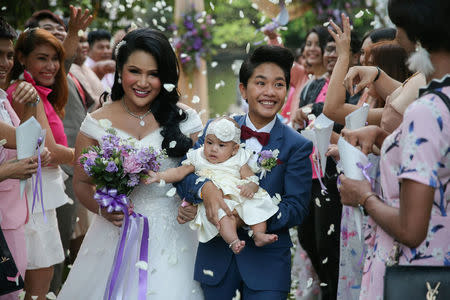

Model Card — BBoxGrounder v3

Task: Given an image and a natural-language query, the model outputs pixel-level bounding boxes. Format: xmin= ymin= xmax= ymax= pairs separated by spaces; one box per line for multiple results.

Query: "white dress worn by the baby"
xmin=182 ymin=147 xmax=278 ymax=243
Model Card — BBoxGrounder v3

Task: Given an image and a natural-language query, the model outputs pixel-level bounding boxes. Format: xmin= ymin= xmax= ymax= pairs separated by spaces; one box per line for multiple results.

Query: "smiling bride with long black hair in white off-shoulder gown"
xmin=58 ymin=29 xmax=203 ymax=300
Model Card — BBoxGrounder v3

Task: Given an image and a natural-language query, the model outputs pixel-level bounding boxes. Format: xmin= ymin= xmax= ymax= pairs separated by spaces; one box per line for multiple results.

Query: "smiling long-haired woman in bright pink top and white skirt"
xmin=7 ymin=28 xmax=74 ymax=299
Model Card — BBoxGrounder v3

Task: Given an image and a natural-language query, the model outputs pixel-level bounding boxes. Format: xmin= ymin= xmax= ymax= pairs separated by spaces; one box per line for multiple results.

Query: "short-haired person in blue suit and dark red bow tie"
xmin=177 ymin=46 xmax=312 ymax=300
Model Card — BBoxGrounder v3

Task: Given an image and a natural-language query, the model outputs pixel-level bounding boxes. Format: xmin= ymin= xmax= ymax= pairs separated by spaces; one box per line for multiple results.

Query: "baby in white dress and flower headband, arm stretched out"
xmin=146 ymin=117 xmax=278 ymax=254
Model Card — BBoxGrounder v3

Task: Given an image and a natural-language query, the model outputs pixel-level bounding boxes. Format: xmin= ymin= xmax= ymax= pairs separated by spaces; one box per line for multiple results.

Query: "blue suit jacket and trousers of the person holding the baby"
xmin=177 ymin=115 xmax=312 ymax=291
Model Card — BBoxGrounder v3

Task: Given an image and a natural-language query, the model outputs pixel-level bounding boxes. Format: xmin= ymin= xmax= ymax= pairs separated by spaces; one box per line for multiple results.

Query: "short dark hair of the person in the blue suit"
xmin=239 ymin=45 xmax=294 ymax=89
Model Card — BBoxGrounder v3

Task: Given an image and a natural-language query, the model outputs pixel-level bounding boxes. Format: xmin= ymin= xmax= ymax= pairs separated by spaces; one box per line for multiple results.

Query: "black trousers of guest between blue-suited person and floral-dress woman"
xmin=298 ymin=176 xmax=342 ymax=300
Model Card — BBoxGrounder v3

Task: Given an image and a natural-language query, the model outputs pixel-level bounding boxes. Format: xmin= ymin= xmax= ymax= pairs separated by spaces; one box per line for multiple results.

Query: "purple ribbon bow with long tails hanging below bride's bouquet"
xmin=94 ymin=187 xmax=149 ymax=300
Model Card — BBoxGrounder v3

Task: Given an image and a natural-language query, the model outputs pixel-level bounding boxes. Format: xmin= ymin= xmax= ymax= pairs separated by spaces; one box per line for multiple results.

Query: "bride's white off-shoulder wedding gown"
xmin=58 ymin=109 xmax=203 ymax=300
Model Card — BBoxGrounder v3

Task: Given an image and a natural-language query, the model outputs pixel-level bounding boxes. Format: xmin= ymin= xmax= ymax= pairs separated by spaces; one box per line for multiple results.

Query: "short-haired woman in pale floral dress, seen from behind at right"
xmin=341 ymin=0 xmax=450 ymax=299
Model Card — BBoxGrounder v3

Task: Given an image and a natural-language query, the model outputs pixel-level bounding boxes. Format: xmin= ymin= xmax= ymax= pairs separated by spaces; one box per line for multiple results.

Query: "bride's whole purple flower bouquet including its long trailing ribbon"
xmin=79 ymin=126 xmax=166 ymax=300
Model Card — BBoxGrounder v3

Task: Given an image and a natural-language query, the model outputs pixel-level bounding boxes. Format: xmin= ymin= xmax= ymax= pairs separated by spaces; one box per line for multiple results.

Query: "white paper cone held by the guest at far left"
xmin=16 ymin=117 xmax=42 ymax=199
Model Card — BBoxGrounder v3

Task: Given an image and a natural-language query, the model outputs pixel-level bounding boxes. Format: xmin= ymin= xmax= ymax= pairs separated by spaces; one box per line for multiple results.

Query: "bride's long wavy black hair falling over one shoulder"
xmin=103 ymin=28 xmax=192 ymax=157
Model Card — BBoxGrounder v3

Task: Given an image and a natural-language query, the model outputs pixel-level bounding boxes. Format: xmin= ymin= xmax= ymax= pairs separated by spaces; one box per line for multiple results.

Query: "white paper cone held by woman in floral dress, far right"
xmin=338 ymin=137 xmax=369 ymax=240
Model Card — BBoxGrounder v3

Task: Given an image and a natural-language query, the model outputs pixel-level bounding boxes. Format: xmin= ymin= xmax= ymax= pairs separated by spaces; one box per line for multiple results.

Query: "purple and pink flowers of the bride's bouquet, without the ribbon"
xmin=79 ymin=128 xmax=166 ymax=196
